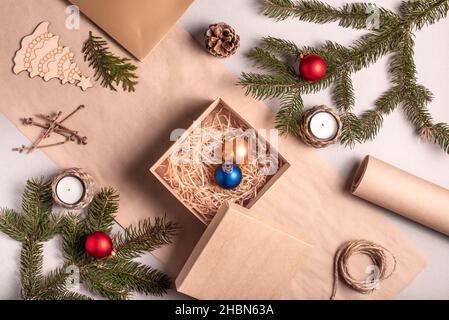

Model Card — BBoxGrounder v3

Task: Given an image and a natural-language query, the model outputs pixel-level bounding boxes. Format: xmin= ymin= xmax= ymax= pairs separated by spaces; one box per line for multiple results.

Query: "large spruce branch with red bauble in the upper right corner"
xmin=239 ymin=0 xmax=449 ymax=153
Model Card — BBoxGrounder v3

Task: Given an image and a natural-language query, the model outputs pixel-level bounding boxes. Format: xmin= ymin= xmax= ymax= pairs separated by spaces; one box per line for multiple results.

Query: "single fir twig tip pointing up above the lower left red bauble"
xmin=87 ymin=188 xmax=119 ymax=233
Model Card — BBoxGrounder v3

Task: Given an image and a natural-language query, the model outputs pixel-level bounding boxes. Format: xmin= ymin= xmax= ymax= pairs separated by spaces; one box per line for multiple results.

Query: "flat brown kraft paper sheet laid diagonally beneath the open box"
xmin=0 ymin=0 xmax=426 ymax=299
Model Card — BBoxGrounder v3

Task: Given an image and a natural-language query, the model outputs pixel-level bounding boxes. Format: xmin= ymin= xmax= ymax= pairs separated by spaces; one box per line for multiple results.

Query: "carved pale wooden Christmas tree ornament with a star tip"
xmin=13 ymin=21 xmax=93 ymax=91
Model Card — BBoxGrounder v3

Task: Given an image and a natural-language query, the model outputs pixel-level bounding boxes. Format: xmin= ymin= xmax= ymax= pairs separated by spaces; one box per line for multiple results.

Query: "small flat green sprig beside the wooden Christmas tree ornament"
xmin=82 ymin=31 xmax=138 ymax=92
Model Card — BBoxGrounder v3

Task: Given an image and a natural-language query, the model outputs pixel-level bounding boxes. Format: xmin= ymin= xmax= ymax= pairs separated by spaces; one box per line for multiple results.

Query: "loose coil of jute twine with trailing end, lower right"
xmin=330 ymin=240 xmax=397 ymax=300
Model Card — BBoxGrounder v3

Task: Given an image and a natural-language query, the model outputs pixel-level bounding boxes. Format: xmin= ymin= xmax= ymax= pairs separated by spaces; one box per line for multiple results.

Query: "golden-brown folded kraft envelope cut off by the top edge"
xmin=69 ymin=0 xmax=194 ymax=60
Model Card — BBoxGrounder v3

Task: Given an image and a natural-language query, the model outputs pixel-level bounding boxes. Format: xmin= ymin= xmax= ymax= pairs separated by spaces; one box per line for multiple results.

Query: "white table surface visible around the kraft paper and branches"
xmin=0 ymin=0 xmax=449 ymax=299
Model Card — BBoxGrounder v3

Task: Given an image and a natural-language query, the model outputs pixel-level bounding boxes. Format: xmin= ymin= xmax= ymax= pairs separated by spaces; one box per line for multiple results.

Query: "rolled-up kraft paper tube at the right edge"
xmin=352 ymin=156 xmax=449 ymax=235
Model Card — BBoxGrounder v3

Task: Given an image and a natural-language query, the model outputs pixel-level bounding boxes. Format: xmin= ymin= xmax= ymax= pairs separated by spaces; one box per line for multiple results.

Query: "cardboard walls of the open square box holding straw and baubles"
xmin=150 ymin=98 xmax=290 ymax=225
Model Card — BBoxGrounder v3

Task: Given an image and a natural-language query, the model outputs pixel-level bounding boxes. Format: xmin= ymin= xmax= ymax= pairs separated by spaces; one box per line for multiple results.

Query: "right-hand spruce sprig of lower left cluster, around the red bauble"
xmin=62 ymin=188 xmax=177 ymax=299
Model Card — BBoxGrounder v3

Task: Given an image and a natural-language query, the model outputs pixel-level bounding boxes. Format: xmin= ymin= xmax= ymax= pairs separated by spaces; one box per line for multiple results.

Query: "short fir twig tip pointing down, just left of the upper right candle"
xmin=275 ymin=91 xmax=304 ymax=136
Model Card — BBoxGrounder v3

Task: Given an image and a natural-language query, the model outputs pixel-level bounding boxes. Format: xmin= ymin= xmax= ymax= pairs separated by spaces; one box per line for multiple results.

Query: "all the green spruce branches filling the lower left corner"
xmin=0 ymin=179 xmax=177 ymax=300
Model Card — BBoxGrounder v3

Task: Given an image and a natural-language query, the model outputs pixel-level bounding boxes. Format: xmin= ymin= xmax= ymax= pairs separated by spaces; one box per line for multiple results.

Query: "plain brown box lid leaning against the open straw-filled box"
xmin=176 ymin=203 xmax=312 ymax=300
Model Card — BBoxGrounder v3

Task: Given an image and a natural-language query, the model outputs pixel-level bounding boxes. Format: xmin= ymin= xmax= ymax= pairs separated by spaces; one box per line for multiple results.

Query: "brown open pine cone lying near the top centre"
xmin=204 ymin=22 xmax=240 ymax=58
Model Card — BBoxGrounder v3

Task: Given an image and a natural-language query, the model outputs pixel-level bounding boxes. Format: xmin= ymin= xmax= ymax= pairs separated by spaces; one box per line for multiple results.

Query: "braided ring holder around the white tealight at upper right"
xmin=300 ymin=105 xmax=342 ymax=148
